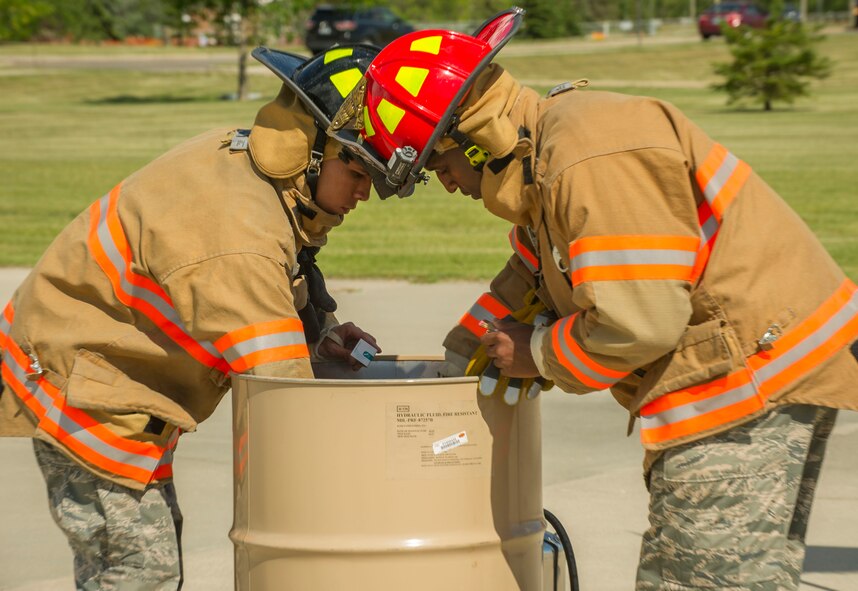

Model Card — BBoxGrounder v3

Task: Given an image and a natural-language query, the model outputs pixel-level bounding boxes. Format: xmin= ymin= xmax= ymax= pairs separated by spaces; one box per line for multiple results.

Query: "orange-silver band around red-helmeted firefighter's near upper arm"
xmin=569 ymin=235 xmax=700 ymax=286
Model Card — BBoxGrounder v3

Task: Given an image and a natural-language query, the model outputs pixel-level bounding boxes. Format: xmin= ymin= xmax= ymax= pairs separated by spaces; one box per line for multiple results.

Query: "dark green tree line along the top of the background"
xmin=0 ymin=0 xmax=851 ymax=45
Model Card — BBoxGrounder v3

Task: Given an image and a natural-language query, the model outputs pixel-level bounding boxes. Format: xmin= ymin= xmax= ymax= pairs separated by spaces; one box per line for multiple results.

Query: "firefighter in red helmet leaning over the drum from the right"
xmin=330 ymin=9 xmax=858 ymax=591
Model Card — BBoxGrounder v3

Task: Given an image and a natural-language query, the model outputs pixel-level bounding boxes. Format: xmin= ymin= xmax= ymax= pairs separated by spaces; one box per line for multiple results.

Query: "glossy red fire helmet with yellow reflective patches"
xmin=333 ymin=8 xmax=524 ymax=197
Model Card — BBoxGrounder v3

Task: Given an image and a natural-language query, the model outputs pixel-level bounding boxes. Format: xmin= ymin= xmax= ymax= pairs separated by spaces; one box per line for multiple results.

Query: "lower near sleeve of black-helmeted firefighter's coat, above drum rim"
xmin=162 ymin=253 xmax=313 ymax=378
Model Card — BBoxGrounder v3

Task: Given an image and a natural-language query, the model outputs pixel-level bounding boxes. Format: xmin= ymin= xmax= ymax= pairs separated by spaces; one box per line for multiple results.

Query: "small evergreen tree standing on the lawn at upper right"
xmin=712 ymin=12 xmax=831 ymax=111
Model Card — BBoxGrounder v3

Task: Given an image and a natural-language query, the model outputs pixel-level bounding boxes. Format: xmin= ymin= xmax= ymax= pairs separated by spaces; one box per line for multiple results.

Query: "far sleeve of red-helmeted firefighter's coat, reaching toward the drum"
xmin=444 ymin=226 xmax=537 ymax=363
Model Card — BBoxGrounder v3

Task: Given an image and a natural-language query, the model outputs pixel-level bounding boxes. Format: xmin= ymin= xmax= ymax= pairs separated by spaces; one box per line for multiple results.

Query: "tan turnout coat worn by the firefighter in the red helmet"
xmin=445 ymin=69 xmax=858 ymax=458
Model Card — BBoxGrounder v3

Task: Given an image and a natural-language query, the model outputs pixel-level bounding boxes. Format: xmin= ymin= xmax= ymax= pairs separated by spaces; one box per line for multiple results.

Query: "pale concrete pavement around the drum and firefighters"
xmin=0 ymin=269 xmax=858 ymax=591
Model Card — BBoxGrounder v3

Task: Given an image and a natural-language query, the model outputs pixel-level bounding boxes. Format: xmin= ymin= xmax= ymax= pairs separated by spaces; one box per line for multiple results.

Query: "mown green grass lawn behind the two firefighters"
xmin=0 ymin=33 xmax=858 ymax=281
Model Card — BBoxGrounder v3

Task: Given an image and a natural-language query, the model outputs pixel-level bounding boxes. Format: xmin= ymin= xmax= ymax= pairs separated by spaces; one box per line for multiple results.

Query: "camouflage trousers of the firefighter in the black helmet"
xmin=33 ymin=439 xmax=182 ymax=591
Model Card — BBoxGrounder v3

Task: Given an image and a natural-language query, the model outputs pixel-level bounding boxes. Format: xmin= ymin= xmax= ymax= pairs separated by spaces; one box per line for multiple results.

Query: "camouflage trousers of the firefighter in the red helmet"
xmin=635 ymin=405 xmax=837 ymax=591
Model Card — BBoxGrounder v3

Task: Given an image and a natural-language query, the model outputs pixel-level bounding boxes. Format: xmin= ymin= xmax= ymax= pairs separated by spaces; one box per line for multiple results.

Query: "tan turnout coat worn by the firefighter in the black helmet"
xmin=0 ymin=87 xmax=341 ymax=488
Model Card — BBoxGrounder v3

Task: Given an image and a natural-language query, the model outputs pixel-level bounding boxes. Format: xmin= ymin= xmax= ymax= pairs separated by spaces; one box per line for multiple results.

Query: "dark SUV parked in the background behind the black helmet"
xmin=304 ymin=5 xmax=414 ymax=53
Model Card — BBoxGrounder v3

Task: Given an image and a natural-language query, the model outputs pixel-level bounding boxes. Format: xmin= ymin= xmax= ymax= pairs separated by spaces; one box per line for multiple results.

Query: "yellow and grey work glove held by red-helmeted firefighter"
xmin=465 ymin=290 xmax=554 ymax=406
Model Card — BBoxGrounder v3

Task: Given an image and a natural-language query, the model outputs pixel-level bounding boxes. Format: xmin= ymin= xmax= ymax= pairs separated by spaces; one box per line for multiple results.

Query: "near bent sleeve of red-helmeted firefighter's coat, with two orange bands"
xmin=536 ymin=148 xmax=700 ymax=393
